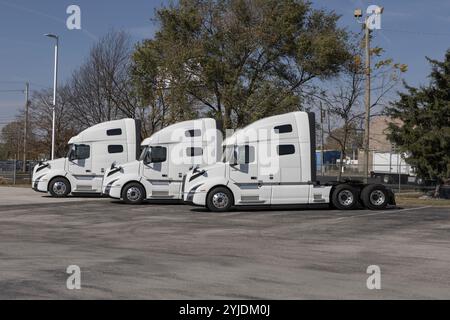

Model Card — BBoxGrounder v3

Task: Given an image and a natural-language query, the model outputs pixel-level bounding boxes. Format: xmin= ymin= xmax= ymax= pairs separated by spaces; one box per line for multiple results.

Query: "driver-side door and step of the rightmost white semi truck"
xmin=230 ymin=142 xmax=271 ymax=205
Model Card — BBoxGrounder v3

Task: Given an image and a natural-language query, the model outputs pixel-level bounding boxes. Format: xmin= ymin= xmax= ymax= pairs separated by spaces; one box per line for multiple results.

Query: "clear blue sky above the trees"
xmin=0 ymin=0 xmax=450 ymax=127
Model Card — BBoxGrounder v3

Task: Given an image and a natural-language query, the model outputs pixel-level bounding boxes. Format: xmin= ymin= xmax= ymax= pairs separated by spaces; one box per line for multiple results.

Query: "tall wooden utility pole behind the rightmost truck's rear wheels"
xmin=364 ymin=18 xmax=370 ymax=183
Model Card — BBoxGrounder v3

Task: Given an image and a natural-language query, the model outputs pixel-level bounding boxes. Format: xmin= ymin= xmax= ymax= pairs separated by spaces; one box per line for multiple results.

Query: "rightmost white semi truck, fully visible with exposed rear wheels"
xmin=182 ymin=112 xmax=395 ymax=211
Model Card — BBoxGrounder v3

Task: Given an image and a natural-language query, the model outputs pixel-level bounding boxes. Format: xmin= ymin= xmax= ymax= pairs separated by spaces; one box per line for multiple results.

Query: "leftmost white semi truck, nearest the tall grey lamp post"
xmin=32 ymin=119 xmax=141 ymax=197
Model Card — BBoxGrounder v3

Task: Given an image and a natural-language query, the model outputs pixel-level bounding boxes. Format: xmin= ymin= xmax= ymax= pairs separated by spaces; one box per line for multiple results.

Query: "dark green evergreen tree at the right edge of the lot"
xmin=388 ymin=49 xmax=450 ymax=197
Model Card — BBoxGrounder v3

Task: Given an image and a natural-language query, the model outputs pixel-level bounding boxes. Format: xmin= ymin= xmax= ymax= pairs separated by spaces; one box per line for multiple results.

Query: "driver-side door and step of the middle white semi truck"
xmin=143 ymin=146 xmax=169 ymax=199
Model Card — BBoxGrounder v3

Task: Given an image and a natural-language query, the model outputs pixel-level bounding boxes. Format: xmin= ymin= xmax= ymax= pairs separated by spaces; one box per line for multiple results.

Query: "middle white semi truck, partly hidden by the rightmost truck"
xmin=103 ymin=118 xmax=222 ymax=204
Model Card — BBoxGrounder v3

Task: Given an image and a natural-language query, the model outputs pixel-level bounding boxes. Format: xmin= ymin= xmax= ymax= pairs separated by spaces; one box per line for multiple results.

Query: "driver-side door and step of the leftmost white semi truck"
xmin=67 ymin=144 xmax=95 ymax=192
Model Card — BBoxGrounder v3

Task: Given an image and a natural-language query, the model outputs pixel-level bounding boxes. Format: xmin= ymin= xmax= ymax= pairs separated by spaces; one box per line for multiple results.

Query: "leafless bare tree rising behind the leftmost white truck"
xmin=68 ymin=31 xmax=142 ymax=127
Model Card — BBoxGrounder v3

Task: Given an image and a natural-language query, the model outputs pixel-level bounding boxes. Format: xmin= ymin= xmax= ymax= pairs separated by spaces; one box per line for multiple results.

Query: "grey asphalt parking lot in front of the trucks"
xmin=0 ymin=188 xmax=450 ymax=299
